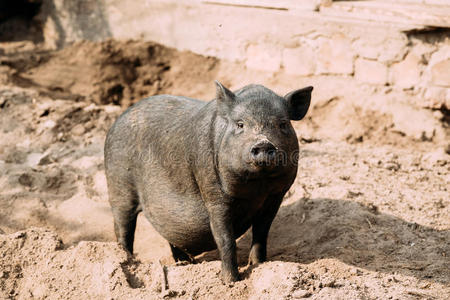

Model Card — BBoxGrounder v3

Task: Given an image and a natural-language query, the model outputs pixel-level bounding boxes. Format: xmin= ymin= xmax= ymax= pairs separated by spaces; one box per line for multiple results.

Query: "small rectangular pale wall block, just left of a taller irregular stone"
xmin=355 ymin=58 xmax=388 ymax=85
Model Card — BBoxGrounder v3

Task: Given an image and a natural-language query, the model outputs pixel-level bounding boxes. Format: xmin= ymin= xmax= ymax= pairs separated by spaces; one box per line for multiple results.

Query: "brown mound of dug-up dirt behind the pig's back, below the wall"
xmin=0 ymin=40 xmax=218 ymax=106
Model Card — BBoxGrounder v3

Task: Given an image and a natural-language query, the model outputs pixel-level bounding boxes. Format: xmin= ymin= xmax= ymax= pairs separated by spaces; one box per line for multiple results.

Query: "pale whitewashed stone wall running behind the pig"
xmin=37 ymin=0 xmax=450 ymax=109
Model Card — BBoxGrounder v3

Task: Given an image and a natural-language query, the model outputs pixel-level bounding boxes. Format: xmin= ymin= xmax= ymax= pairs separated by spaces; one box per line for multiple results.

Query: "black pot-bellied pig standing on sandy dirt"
xmin=104 ymin=81 xmax=313 ymax=283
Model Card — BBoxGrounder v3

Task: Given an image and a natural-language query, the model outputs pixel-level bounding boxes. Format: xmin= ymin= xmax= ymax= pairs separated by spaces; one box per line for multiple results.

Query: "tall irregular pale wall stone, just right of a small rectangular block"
xmin=389 ymin=53 xmax=421 ymax=89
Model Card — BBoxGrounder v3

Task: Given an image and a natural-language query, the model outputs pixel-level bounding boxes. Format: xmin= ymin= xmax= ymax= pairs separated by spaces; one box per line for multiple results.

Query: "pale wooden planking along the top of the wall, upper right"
xmin=201 ymin=0 xmax=450 ymax=31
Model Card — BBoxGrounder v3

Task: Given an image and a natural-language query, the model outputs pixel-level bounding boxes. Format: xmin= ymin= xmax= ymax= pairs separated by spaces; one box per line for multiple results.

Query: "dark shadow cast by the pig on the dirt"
xmin=199 ymin=199 xmax=450 ymax=284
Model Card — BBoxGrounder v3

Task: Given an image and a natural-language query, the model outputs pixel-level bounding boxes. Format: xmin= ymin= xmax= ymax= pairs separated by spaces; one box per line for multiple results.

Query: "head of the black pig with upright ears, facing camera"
xmin=215 ymin=81 xmax=313 ymax=186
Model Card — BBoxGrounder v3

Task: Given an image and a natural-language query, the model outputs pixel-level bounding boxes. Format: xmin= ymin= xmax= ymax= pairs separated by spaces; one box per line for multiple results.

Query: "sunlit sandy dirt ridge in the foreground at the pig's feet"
xmin=0 ymin=228 xmax=449 ymax=299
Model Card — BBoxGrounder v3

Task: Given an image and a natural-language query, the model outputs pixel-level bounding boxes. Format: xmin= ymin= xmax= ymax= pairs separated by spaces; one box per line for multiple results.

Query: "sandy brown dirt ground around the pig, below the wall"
xmin=0 ymin=40 xmax=450 ymax=299
